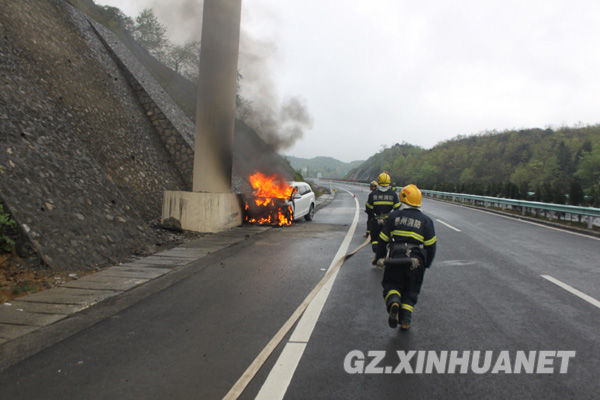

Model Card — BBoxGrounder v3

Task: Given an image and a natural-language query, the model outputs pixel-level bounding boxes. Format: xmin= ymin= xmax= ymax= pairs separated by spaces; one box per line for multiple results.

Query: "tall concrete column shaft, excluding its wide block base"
xmin=192 ymin=0 xmax=242 ymax=193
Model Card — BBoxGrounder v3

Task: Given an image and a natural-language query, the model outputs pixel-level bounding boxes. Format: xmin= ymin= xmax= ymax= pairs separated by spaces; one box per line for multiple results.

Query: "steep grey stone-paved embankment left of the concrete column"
xmin=0 ymin=0 xmax=290 ymax=270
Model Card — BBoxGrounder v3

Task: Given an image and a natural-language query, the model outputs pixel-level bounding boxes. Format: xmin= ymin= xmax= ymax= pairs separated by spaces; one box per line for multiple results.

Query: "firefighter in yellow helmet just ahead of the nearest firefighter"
xmin=365 ymin=172 xmax=400 ymax=256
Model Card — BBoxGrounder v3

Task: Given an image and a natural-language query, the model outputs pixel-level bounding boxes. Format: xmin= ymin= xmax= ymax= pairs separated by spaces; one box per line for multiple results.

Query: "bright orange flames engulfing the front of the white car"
xmin=246 ymin=172 xmax=294 ymax=226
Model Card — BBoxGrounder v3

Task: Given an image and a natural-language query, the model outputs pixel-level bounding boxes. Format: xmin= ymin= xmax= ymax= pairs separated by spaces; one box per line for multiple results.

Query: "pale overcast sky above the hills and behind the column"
xmin=96 ymin=0 xmax=600 ymax=162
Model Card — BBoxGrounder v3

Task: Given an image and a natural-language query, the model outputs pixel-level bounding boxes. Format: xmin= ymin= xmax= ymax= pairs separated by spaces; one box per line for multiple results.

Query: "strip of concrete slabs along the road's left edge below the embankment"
xmin=0 ymin=225 xmax=272 ymax=371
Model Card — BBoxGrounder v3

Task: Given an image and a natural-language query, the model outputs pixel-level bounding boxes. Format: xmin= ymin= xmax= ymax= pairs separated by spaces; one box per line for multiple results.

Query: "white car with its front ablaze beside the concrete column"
xmin=245 ymin=172 xmax=315 ymax=226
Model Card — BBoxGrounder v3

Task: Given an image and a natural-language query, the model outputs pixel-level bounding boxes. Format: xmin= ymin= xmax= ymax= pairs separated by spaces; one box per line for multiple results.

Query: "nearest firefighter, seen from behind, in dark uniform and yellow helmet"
xmin=376 ymin=185 xmax=437 ymax=330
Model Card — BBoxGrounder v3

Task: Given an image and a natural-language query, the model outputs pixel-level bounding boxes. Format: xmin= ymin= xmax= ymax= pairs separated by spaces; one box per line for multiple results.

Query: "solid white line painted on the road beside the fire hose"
xmin=255 ymin=189 xmax=359 ymax=400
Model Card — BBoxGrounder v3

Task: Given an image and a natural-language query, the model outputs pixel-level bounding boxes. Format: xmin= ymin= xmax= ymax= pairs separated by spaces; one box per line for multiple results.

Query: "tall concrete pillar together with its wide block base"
xmin=162 ymin=0 xmax=242 ymax=232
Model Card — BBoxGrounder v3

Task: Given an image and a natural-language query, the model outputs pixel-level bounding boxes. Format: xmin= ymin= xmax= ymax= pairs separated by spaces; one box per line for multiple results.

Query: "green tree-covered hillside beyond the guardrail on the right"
xmin=347 ymin=125 xmax=600 ymax=207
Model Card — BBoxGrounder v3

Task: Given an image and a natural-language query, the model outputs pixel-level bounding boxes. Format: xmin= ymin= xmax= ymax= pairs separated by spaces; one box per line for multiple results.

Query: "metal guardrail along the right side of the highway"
xmin=421 ymin=190 xmax=600 ymax=229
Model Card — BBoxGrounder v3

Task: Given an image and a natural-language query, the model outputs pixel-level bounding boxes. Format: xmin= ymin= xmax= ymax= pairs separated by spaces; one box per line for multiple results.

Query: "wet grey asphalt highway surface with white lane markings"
xmin=0 ymin=185 xmax=600 ymax=400
